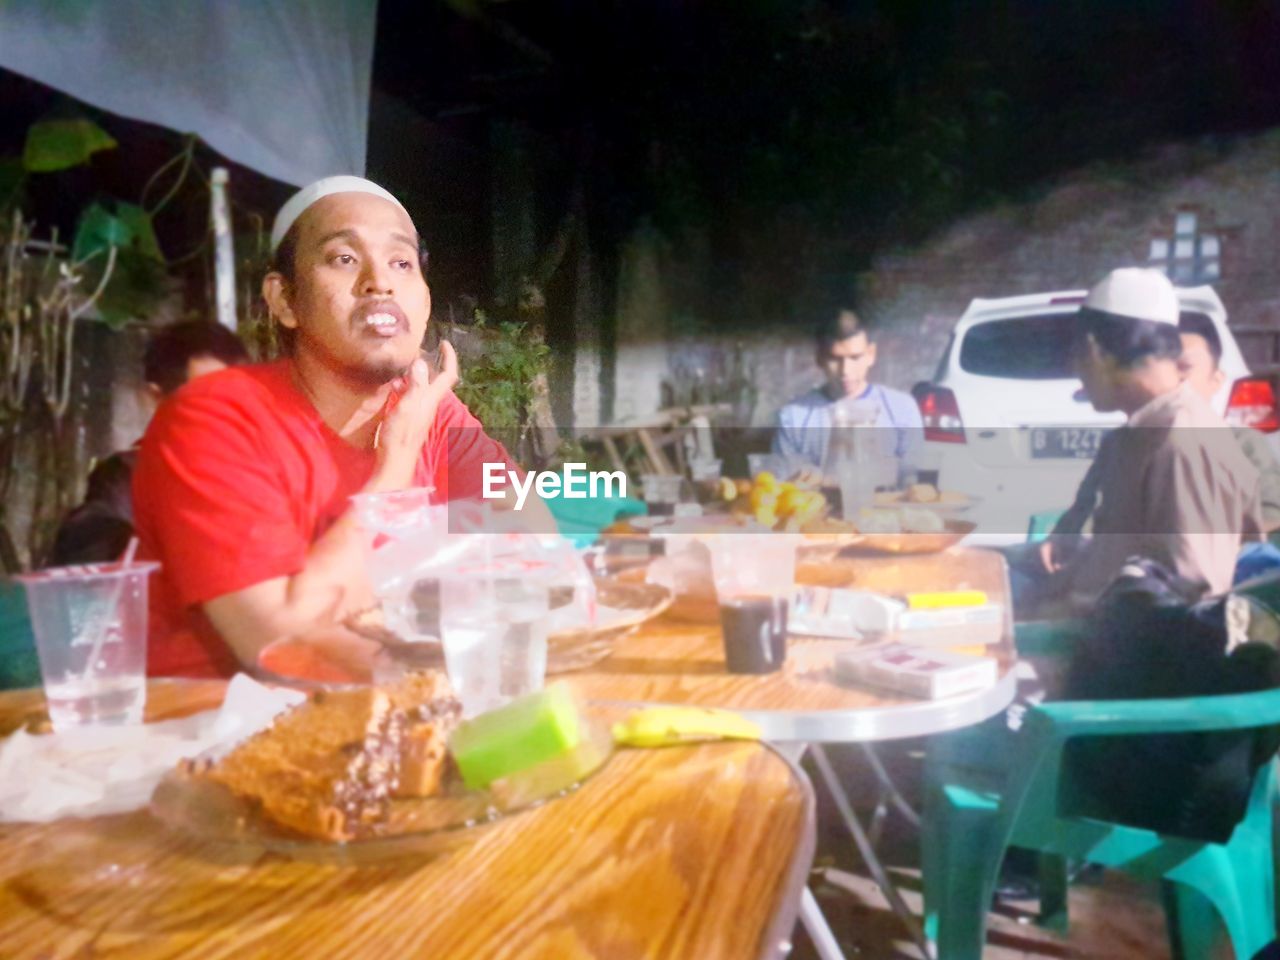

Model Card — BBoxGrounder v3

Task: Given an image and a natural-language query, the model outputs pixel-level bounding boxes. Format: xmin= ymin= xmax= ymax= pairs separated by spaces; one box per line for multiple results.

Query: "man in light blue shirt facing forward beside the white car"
xmin=773 ymin=306 xmax=924 ymax=483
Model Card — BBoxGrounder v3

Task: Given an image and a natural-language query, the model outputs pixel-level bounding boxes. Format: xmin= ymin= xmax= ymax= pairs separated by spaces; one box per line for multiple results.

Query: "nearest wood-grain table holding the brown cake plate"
xmin=0 ymin=681 xmax=814 ymax=960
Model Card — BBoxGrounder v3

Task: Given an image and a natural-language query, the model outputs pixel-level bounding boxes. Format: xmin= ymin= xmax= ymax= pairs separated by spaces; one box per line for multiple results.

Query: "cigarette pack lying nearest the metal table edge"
xmin=836 ymin=644 xmax=997 ymax=700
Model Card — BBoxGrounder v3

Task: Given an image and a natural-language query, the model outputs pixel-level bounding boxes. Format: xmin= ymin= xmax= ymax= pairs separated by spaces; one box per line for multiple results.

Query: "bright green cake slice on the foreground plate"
xmin=449 ymin=684 xmax=582 ymax=790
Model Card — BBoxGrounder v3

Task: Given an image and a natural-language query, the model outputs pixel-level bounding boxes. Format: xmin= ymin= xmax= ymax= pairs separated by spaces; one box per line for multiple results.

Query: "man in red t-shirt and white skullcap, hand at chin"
xmin=133 ymin=177 xmax=554 ymax=676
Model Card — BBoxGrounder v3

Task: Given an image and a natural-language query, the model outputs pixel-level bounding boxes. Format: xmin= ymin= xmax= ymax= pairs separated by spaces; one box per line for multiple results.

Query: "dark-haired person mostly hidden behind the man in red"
xmin=49 ymin=320 xmax=248 ymax=567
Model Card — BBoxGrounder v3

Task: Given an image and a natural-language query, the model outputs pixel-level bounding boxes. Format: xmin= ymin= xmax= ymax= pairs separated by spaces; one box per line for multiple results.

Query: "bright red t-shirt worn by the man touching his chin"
xmin=133 ymin=361 xmax=511 ymax=677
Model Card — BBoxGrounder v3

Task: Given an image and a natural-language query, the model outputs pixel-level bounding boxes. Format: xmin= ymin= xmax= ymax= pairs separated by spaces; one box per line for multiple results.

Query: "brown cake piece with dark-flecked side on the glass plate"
xmin=182 ymin=671 xmax=462 ymax=841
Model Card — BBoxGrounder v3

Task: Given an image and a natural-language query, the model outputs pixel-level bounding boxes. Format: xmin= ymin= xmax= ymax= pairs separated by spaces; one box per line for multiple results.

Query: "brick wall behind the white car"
xmin=859 ymin=131 xmax=1280 ymax=387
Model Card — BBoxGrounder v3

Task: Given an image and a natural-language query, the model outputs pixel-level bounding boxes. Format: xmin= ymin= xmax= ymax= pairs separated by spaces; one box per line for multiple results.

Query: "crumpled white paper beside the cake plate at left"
xmin=0 ymin=673 xmax=306 ymax=822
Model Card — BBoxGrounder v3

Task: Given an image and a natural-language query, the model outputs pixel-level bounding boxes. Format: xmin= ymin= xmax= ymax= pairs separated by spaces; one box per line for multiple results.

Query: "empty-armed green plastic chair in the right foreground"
xmin=923 ymin=690 xmax=1280 ymax=960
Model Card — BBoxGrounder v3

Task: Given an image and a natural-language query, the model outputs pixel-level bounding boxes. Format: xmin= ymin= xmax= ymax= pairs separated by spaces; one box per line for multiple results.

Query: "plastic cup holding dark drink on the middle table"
xmin=710 ymin=534 xmax=799 ymax=673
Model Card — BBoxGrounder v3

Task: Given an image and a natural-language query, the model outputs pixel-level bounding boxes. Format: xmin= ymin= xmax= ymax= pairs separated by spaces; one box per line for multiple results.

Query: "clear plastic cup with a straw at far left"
xmin=18 ymin=563 xmax=160 ymax=730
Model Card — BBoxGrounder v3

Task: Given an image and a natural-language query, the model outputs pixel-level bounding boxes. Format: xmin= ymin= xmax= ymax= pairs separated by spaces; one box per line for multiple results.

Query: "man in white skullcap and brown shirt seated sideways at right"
xmin=1012 ymin=268 xmax=1262 ymax=616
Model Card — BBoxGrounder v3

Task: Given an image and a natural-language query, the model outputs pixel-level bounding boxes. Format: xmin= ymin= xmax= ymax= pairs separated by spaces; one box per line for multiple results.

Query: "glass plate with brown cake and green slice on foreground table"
xmin=151 ymin=671 xmax=613 ymax=861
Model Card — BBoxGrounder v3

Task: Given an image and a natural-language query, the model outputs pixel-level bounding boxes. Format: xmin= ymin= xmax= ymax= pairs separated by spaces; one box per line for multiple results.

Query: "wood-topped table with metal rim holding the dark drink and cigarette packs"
xmin=564 ymin=549 xmax=1016 ymax=742
